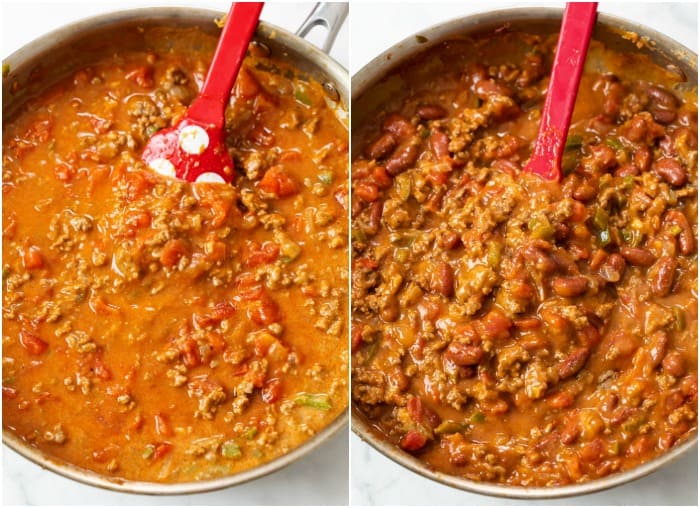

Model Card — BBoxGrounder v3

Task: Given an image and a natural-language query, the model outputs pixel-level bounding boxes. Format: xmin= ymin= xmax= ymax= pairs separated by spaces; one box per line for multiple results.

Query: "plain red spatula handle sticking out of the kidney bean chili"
xmin=525 ymin=2 xmax=598 ymax=181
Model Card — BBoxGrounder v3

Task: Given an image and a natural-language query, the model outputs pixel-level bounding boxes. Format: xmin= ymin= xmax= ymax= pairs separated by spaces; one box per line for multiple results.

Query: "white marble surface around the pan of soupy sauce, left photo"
xmin=0 ymin=0 xmax=349 ymax=506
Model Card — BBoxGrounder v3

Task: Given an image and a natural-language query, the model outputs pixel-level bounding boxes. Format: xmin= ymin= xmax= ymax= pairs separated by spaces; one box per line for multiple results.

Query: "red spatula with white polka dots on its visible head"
xmin=141 ymin=2 xmax=263 ymax=183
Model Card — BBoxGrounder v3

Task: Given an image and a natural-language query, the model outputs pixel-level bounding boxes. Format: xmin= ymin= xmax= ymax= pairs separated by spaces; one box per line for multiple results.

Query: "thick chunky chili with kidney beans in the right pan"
xmin=352 ymin=29 xmax=698 ymax=486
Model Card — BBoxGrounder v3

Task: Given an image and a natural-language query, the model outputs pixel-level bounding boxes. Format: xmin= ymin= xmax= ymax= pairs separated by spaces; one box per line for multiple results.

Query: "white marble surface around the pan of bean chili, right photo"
xmin=350 ymin=2 xmax=698 ymax=506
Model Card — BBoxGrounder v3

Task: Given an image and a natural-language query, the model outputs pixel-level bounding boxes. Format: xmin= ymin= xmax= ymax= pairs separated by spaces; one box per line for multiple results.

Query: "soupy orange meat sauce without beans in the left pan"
xmin=2 ymin=27 xmax=348 ymax=482
